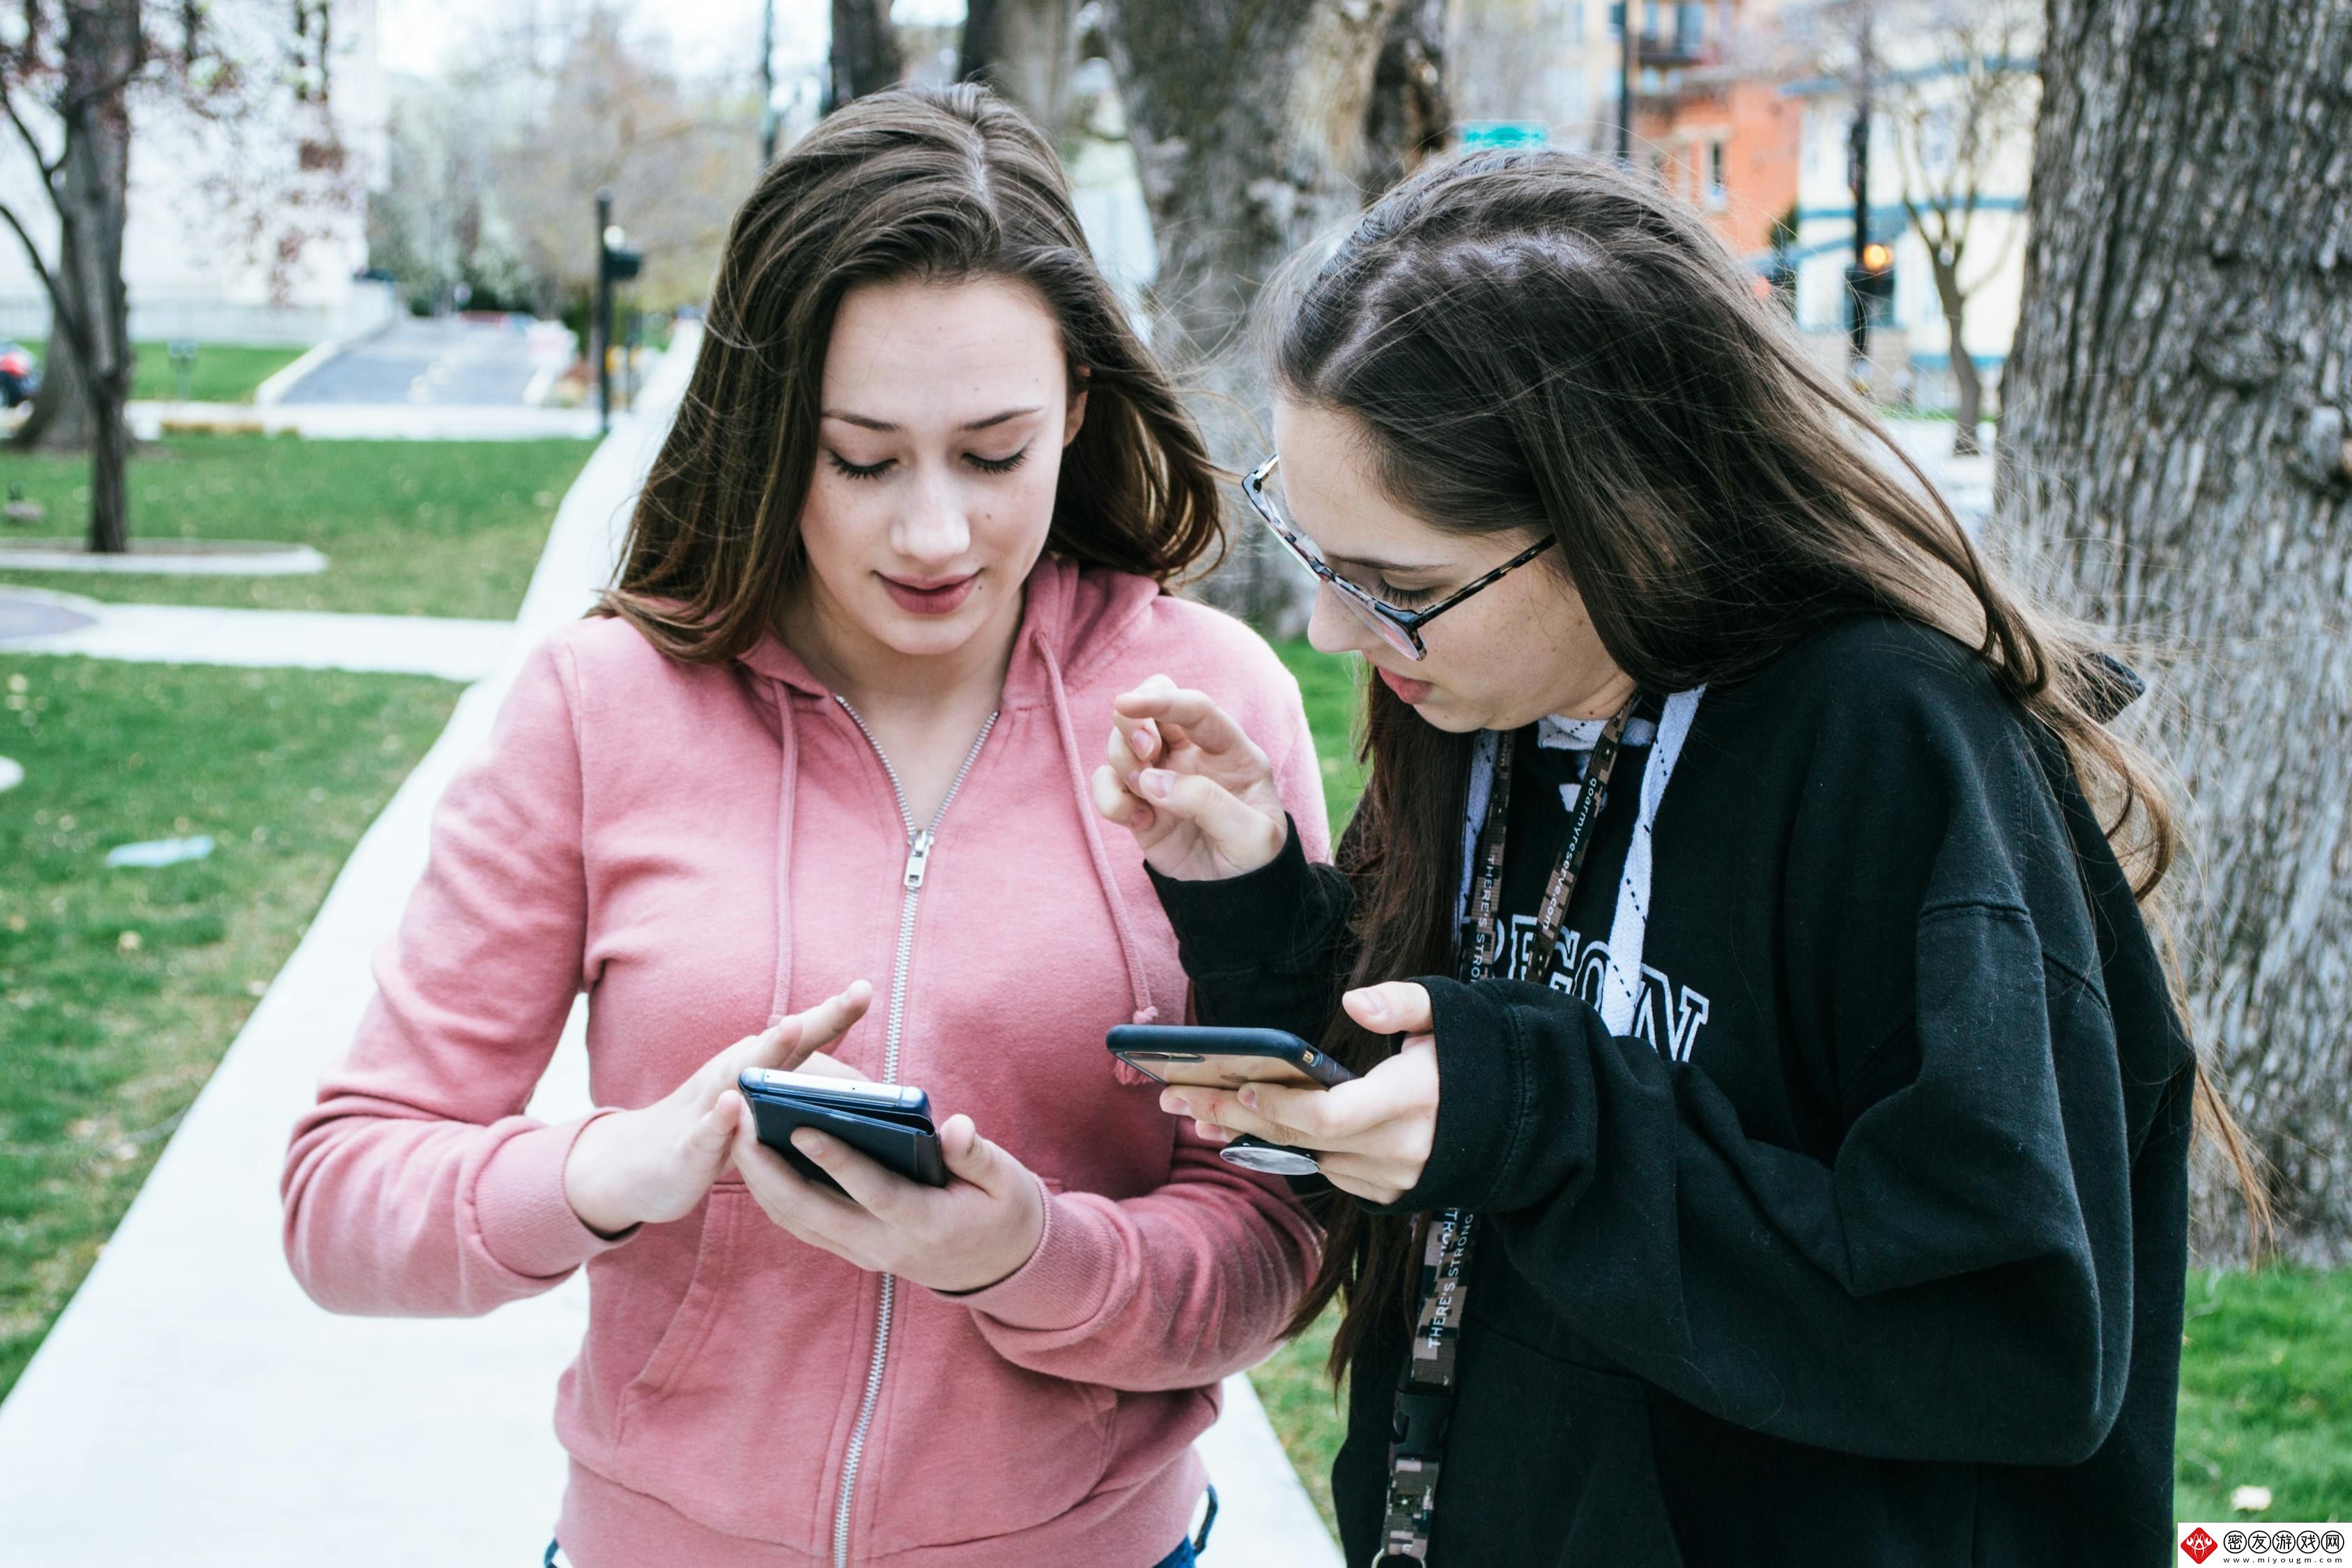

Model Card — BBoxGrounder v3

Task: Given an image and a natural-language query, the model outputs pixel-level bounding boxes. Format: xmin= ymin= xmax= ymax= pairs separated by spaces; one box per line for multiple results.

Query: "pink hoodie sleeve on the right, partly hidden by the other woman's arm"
xmin=953 ymin=666 xmax=1331 ymax=1390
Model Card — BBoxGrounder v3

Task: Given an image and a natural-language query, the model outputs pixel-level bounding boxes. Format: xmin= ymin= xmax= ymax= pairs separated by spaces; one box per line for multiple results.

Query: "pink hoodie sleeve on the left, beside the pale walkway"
xmin=280 ymin=644 xmax=619 ymax=1316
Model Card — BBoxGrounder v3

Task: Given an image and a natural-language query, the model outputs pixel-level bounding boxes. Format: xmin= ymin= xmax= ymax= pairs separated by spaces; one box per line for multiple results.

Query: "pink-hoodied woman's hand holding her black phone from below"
xmin=734 ymin=1107 xmax=1045 ymax=1291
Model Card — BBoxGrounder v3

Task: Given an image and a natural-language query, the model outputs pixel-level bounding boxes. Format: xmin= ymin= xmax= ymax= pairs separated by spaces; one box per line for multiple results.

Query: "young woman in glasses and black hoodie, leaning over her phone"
xmin=1096 ymin=153 xmax=2253 ymax=1568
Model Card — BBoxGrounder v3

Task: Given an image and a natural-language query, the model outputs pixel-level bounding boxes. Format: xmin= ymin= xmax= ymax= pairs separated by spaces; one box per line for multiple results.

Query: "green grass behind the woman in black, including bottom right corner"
xmin=1249 ymin=642 xmax=2352 ymax=1523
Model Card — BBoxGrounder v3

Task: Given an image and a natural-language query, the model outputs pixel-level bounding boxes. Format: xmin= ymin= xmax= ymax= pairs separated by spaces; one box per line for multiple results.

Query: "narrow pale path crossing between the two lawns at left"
xmin=0 ymin=587 xmax=515 ymax=682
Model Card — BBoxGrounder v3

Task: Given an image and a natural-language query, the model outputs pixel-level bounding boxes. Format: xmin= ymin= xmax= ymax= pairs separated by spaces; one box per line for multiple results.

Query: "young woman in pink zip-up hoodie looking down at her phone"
xmin=284 ymin=87 xmax=1324 ymax=1568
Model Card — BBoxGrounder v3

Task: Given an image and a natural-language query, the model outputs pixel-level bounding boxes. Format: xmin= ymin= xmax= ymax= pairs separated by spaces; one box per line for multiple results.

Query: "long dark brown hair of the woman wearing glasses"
xmin=1273 ymin=151 xmax=2268 ymax=1373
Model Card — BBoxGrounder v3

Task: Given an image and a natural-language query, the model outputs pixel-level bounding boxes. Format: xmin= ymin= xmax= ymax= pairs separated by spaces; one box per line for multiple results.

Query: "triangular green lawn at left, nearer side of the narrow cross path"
xmin=0 ymin=654 xmax=459 ymax=1394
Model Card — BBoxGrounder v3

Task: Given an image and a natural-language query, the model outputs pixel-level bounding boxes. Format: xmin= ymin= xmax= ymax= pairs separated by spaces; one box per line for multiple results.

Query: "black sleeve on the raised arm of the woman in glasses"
xmin=1150 ymin=823 xmax=1353 ymax=1041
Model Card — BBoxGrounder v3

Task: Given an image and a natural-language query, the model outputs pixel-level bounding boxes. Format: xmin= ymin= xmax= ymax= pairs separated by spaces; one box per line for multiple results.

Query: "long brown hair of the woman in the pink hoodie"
xmin=600 ymin=84 xmax=1223 ymax=663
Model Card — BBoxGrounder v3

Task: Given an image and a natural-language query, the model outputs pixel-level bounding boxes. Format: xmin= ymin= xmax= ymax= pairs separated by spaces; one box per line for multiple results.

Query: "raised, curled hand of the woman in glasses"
xmin=1093 ymin=675 xmax=1291 ymax=882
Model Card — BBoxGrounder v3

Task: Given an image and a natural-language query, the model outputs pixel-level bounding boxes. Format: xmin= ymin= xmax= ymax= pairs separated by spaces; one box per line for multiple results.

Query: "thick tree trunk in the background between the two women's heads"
xmin=1103 ymin=0 xmax=1444 ymax=637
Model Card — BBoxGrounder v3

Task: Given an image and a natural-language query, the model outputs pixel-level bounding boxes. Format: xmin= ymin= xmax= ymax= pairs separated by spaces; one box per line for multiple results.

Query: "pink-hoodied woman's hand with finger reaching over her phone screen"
xmin=564 ymin=981 xmax=875 ymax=1236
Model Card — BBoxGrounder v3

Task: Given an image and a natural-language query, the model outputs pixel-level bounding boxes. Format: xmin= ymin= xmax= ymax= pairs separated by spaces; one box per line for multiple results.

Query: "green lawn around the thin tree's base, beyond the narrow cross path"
xmin=0 ymin=435 xmax=595 ymax=621
